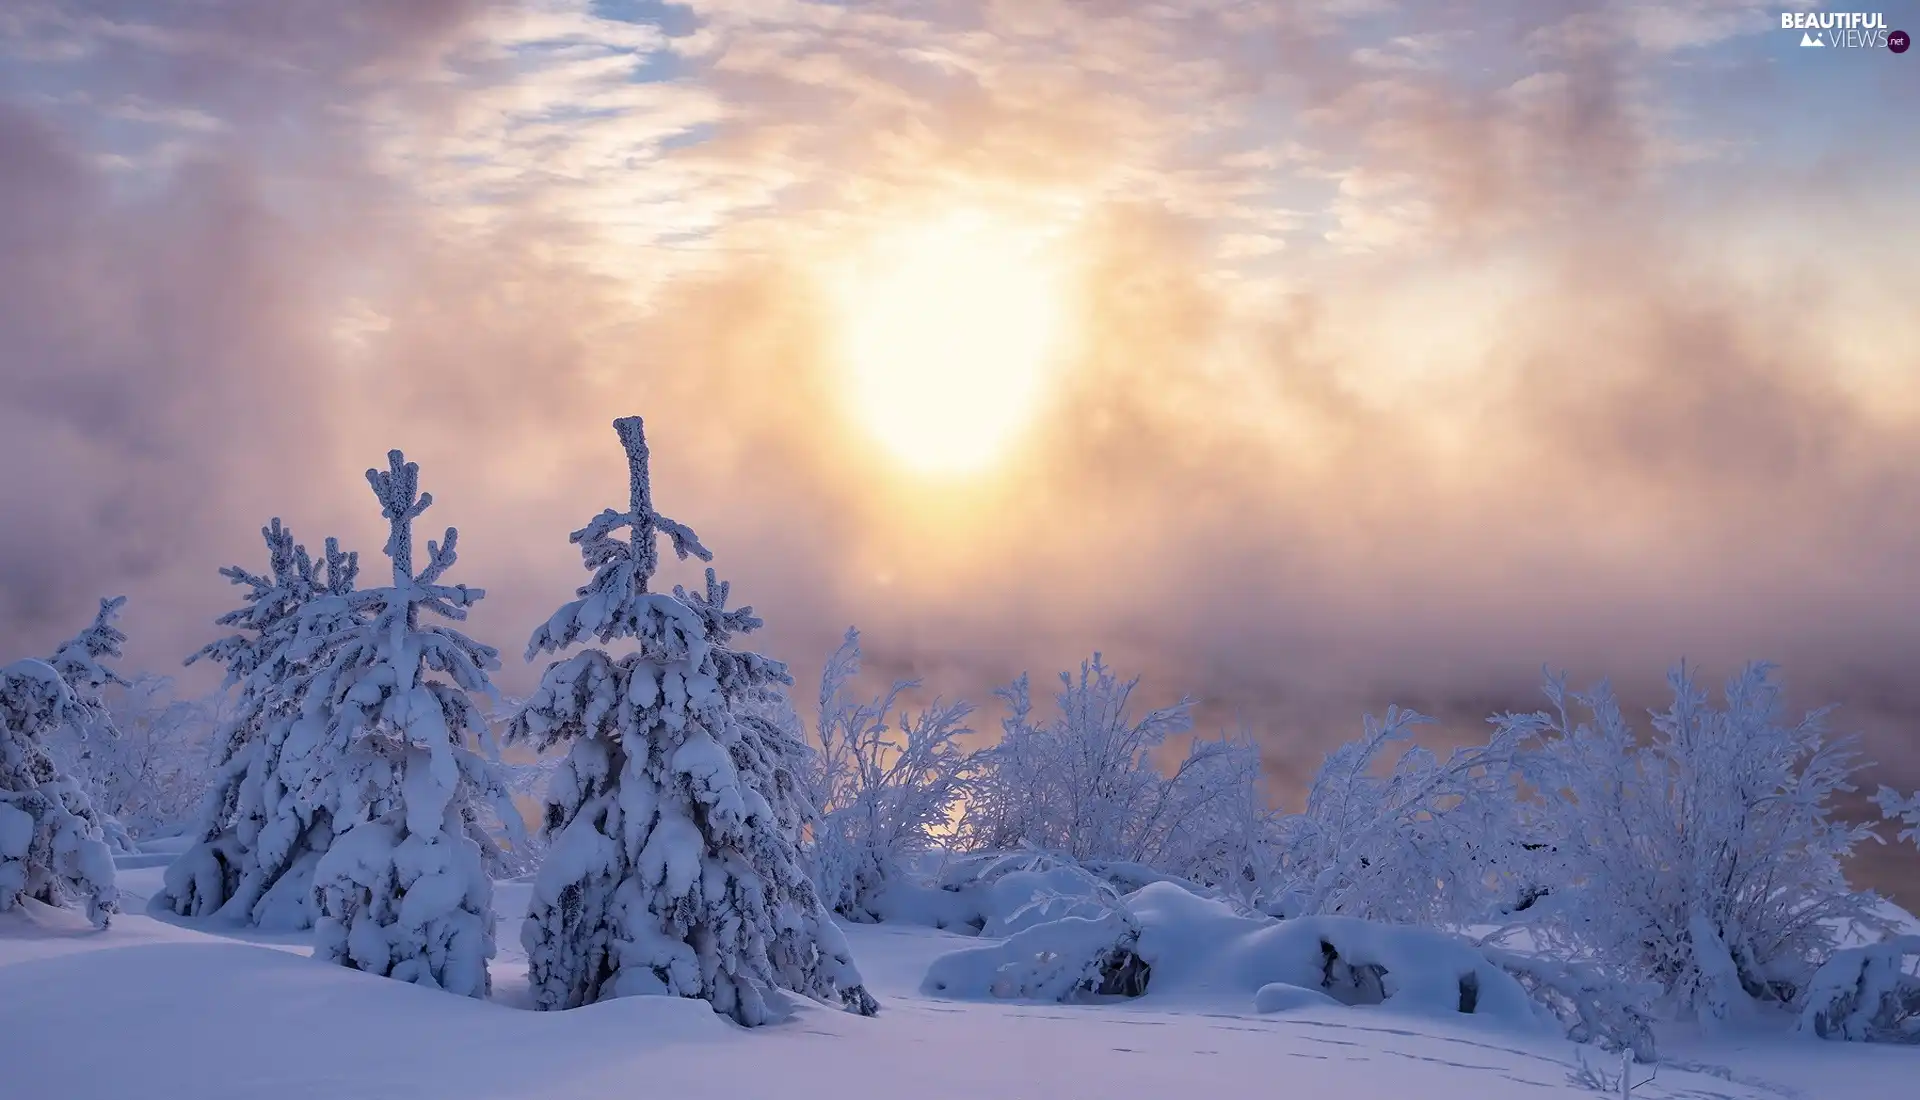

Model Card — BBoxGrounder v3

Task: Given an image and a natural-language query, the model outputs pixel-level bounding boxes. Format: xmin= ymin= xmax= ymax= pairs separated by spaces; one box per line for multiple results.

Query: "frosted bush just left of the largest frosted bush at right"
xmin=1261 ymin=708 xmax=1524 ymax=925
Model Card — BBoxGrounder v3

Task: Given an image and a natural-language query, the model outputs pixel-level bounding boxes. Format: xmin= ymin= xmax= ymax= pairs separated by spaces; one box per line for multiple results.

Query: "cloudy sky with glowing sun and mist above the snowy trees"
xmin=0 ymin=0 xmax=1920 ymax=883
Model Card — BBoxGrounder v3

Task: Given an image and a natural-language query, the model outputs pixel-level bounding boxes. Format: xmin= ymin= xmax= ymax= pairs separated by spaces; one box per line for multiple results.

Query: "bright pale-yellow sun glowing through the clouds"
xmin=835 ymin=213 xmax=1068 ymax=474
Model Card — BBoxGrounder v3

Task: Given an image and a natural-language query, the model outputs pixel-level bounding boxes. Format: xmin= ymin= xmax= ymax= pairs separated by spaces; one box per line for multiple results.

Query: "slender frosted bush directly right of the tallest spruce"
xmin=810 ymin=628 xmax=977 ymax=921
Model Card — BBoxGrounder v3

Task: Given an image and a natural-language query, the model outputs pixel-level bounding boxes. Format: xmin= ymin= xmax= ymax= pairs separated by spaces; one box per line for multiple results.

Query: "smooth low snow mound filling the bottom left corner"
xmin=0 ymin=939 xmax=735 ymax=1098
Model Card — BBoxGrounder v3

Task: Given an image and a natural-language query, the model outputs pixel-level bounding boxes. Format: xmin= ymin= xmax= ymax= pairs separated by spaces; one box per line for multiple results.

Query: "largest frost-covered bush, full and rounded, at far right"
xmin=1496 ymin=664 xmax=1874 ymax=1021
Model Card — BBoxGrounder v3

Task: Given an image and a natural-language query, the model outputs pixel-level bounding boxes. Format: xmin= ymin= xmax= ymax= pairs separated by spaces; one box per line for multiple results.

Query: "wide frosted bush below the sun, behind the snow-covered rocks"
xmin=964 ymin=653 xmax=1258 ymax=875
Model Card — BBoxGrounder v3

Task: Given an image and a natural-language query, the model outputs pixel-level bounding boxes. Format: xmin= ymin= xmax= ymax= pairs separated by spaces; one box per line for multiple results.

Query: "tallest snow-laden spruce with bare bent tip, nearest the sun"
xmin=509 ymin=417 xmax=877 ymax=1025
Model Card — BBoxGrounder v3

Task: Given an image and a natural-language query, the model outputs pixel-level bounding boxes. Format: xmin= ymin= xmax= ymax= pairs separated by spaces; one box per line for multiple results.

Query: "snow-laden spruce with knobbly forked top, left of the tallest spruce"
xmin=303 ymin=451 xmax=518 ymax=998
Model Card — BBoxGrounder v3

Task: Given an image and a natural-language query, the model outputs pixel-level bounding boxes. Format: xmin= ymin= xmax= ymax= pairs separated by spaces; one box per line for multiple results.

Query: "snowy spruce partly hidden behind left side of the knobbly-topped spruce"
xmin=156 ymin=518 xmax=359 ymax=931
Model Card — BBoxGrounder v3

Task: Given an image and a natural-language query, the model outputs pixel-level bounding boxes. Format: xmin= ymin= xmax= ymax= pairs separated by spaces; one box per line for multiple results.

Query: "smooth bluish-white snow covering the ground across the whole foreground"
xmin=0 ymin=840 xmax=1920 ymax=1100
